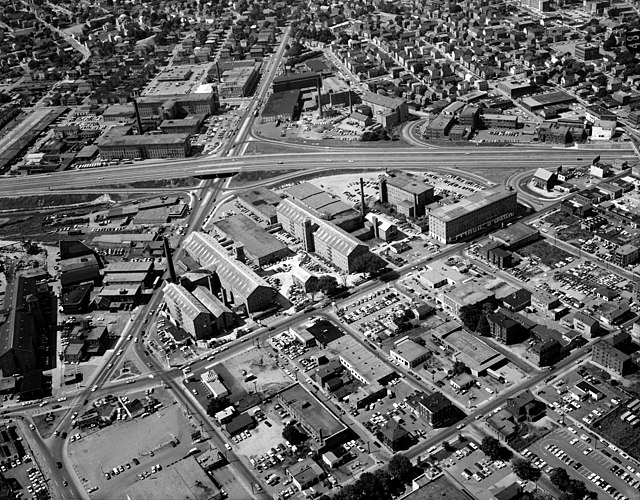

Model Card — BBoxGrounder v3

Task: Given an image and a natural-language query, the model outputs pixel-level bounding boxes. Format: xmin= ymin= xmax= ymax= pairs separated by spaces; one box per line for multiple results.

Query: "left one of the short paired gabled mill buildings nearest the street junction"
xmin=162 ymin=283 xmax=212 ymax=340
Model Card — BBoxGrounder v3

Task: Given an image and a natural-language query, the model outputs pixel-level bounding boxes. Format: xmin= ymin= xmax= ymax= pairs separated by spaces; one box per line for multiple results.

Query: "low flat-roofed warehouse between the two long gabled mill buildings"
xmin=214 ymin=214 xmax=291 ymax=267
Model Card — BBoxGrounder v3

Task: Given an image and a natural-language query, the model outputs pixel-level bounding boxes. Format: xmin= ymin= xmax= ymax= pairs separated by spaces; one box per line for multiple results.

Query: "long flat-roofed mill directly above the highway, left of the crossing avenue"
xmin=98 ymin=127 xmax=191 ymax=160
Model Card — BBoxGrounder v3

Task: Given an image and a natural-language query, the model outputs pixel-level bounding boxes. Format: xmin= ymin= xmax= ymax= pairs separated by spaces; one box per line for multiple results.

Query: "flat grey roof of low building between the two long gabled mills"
xmin=214 ymin=214 xmax=287 ymax=258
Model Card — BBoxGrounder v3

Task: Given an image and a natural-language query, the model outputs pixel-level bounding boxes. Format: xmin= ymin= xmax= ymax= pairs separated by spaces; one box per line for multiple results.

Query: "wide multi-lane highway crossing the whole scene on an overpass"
xmin=0 ymin=147 xmax=636 ymax=196
